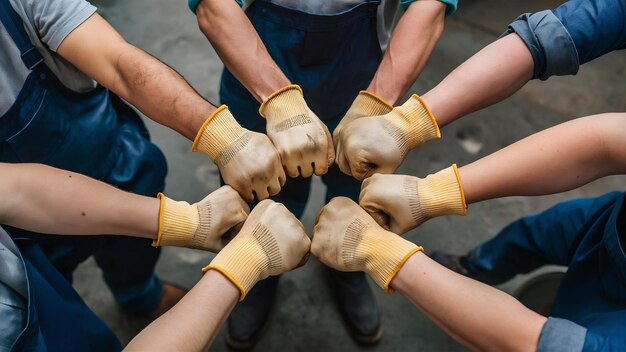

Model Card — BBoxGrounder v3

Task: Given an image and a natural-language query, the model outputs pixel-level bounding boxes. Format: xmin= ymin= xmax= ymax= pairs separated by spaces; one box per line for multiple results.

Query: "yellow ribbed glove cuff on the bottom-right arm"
xmin=342 ymin=219 xmax=424 ymax=294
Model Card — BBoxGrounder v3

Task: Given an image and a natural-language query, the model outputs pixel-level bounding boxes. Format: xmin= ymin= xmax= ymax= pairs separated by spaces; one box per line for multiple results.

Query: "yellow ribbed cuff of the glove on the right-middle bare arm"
xmin=417 ymin=164 xmax=467 ymax=219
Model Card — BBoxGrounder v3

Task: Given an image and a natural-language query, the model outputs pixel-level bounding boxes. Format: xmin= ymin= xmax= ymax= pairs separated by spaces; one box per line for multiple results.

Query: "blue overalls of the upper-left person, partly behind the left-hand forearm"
xmin=0 ymin=0 xmax=167 ymax=313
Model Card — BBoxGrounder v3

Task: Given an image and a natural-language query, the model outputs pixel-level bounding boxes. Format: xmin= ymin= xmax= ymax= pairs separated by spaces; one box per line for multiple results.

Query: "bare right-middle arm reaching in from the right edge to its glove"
xmin=459 ymin=114 xmax=626 ymax=203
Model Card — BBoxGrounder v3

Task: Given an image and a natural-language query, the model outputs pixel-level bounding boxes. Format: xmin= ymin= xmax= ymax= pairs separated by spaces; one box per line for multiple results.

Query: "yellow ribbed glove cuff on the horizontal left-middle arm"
xmin=152 ymin=193 xmax=200 ymax=247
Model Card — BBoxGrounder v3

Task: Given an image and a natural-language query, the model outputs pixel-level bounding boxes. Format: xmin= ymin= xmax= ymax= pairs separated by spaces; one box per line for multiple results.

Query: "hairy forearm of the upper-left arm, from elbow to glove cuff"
xmin=110 ymin=44 xmax=215 ymax=140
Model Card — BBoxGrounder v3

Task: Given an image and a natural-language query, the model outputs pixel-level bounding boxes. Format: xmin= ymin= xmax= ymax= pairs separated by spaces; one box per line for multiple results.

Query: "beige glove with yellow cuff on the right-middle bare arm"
xmin=359 ymin=165 xmax=467 ymax=234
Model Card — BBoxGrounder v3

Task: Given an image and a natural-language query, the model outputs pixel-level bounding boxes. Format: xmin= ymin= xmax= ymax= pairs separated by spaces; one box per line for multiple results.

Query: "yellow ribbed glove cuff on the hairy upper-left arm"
xmin=191 ymin=105 xmax=251 ymax=166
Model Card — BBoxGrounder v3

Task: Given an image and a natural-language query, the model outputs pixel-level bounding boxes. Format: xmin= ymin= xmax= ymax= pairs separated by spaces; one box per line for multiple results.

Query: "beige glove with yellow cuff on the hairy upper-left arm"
xmin=192 ymin=105 xmax=287 ymax=202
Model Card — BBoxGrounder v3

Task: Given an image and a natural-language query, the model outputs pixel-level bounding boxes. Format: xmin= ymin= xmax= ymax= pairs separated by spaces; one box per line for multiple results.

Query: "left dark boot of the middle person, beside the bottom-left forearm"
xmin=226 ymin=276 xmax=280 ymax=350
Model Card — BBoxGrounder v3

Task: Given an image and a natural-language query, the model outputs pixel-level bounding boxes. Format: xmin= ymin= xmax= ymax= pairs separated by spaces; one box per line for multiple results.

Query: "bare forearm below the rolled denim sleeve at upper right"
xmin=422 ymin=34 xmax=534 ymax=127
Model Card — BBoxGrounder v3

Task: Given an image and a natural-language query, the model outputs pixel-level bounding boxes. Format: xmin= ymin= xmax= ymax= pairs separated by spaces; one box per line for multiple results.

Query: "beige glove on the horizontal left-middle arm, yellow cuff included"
xmin=152 ymin=186 xmax=250 ymax=252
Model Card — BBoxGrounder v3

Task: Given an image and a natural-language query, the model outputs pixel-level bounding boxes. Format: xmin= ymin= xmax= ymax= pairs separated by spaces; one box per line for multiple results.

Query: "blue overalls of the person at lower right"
xmin=468 ymin=192 xmax=626 ymax=351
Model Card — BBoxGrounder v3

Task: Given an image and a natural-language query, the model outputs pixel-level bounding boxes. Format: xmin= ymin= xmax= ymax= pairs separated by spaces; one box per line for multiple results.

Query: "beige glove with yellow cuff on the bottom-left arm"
xmin=202 ymin=200 xmax=311 ymax=300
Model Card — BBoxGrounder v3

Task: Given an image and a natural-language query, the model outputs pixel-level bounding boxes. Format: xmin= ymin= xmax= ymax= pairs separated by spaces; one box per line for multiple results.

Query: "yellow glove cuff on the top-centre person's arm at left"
xmin=259 ymin=84 xmax=311 ymax=132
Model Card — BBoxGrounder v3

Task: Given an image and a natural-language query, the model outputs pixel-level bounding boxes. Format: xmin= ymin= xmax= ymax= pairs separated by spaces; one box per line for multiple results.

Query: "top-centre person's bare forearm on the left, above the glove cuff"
xmin=196 ymin=0 xmax=290 ymax=102
